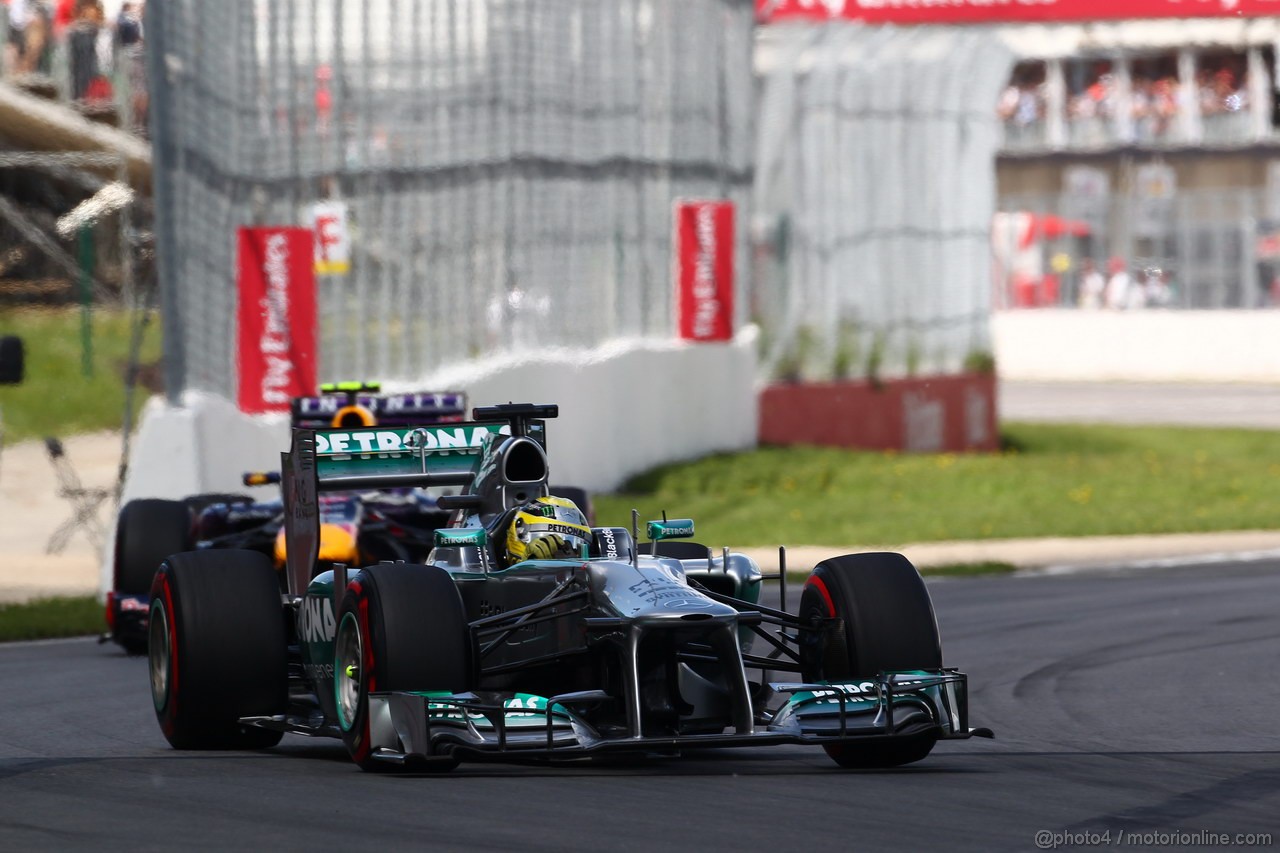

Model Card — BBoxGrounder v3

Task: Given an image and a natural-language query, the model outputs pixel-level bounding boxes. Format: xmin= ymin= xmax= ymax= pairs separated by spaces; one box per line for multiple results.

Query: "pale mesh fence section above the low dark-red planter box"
xmin=753 ymin=23 xmax=1012 ymax=379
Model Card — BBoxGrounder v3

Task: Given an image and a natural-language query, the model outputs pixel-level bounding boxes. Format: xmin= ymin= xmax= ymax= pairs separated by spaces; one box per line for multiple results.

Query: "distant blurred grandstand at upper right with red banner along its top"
xmin=758 ymin=0 xmax=1280 ymax=327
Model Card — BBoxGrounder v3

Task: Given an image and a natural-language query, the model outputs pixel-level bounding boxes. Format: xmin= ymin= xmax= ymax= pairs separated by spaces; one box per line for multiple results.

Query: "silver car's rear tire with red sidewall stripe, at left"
xmin=148 ymin=551 xmax=288 ymax=749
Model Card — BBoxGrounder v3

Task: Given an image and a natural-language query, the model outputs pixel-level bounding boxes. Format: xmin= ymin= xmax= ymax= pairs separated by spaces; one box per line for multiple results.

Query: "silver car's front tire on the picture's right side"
xmin=800 ymin=553 xmax=942 ymax=768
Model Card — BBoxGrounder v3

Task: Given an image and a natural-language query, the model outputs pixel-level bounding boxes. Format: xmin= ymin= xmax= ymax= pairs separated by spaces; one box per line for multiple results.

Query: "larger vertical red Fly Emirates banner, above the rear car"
xmin=237 ymin=228 xmax=316 ymax=414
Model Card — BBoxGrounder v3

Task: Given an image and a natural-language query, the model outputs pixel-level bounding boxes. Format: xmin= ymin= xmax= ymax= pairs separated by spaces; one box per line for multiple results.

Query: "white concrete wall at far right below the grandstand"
xmin=992 ymin=309 xmax=1280 ymax=382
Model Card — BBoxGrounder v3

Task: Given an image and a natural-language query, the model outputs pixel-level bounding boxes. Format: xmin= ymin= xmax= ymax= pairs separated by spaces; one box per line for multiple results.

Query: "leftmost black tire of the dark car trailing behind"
xmin=111 ymin=500 xmax=192 ymax=654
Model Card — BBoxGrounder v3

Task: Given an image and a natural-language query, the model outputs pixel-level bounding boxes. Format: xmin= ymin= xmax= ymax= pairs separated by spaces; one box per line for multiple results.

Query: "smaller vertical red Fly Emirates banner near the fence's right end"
xmin=676 ymin=201 xmax=733 ymax=341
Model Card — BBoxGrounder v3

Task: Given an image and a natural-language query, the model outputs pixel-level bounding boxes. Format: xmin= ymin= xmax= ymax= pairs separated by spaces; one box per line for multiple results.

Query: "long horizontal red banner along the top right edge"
xmin=755 ymin=0 xmax=1280 ymax=24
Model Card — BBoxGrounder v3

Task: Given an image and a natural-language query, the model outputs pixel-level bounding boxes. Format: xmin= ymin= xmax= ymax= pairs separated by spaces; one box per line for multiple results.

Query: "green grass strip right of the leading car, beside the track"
xmin=594 ymin=424 xmax=1280 ymax=547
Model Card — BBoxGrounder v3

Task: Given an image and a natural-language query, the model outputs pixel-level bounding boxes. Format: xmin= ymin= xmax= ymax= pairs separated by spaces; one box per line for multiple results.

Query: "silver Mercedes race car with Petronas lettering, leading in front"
xmin=148 ymin=403 xmax=991 ymax=771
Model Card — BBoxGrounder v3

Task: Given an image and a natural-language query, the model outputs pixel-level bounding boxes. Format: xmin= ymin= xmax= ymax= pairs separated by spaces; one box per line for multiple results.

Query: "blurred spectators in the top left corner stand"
xmin=0 ymin=0 xmax=147 ymax=128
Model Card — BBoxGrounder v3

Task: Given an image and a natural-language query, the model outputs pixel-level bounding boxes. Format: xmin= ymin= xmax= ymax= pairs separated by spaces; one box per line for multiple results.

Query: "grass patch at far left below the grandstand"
xmin=0 ymin=307 xmax=160 ymax=443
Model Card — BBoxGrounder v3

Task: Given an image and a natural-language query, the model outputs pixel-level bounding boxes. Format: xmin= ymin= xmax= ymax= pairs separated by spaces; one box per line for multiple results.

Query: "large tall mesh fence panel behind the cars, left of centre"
xmin=146 ymin=0 xmax=752 ymax=396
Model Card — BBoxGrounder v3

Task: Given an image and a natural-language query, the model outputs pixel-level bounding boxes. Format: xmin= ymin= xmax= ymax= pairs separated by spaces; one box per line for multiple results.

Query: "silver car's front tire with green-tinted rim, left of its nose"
xmin=334 ymin=562 xmax=475 ymax=771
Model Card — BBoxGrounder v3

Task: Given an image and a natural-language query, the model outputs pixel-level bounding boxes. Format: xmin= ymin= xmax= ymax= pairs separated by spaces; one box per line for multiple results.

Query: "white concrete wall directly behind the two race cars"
xmin=102 ymin=327 xmax=758 ymax=590
